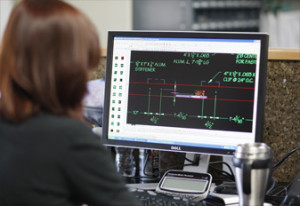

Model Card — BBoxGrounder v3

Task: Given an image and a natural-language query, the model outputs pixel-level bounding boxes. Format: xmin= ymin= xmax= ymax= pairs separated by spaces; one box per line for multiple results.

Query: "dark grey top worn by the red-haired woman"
xmin=0 ymin=113 xmax=141 ymax=206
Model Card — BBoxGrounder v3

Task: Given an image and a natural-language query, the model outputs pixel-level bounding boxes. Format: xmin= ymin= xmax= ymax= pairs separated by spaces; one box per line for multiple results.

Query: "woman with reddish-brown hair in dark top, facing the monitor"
xmin=0 ymin=0 xmax=141 ymax=206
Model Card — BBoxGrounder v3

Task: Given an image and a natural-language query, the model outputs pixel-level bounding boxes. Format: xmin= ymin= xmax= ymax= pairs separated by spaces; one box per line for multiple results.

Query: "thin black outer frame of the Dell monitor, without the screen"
xmin=101 ymin=30 xmax=269 ymax=155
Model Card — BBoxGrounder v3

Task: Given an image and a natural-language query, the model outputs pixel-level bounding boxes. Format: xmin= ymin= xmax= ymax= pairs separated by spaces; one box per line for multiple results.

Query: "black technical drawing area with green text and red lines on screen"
xmin=127 ymin=51 xmax=257 ymax=132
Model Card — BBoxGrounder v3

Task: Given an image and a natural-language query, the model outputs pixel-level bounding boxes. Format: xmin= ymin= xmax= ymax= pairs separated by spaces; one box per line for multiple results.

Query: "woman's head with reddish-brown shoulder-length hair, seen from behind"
xmin=0 ymin=0 xmax=100 ymax=122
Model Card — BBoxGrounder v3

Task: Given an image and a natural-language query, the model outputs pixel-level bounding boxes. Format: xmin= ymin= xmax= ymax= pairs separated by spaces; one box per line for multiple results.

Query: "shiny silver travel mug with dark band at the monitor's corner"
xmin=233 ymin=143 xmax=272 ymax=206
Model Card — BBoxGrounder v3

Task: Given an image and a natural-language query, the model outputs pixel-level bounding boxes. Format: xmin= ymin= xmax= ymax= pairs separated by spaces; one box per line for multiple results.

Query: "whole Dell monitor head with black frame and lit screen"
xmin=102 ymin=31 xmax=268 ymax=155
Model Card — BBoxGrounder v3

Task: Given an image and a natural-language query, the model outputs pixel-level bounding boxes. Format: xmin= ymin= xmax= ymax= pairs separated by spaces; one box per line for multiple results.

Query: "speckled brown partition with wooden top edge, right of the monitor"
xmin=263 ymin=50 xmax=300 ymax=182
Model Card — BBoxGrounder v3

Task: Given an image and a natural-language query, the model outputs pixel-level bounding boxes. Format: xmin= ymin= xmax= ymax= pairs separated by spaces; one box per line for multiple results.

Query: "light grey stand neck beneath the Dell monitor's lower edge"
xmin=183 ymin=153 xmax=210 ymax=173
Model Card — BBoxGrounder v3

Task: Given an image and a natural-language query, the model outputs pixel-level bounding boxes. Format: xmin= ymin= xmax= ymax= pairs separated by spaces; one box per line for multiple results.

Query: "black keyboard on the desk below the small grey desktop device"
xmin=129 ymin=189 xmax=224 ymax=206
